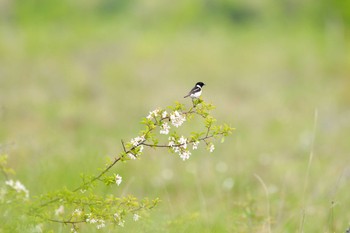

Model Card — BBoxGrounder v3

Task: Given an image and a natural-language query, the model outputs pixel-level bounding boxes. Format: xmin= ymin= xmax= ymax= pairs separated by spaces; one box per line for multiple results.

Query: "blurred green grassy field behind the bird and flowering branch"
xmin=0 ymin=0 xmax=350 ymax=232
